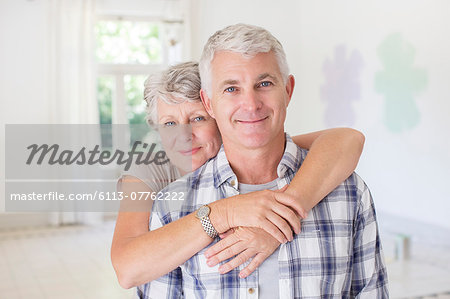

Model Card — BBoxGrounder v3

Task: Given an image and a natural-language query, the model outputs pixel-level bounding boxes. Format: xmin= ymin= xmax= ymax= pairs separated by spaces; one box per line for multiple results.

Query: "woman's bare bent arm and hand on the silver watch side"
xmin=111 ymin=176 xmax=300 ymax=289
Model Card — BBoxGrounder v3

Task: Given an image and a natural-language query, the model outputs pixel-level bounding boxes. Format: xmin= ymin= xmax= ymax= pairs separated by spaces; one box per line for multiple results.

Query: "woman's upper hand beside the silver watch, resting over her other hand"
xmin=209 ymin=187 xmax=306 ymax=243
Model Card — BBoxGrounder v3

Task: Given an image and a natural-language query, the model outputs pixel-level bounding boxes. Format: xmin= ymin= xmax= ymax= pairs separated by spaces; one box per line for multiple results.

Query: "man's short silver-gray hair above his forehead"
xmin=199 ymin=24 xmax=289 ymax=97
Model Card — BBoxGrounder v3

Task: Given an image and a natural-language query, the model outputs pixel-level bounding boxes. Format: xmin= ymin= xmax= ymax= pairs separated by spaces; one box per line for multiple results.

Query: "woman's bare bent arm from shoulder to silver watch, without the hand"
xmin=111 ymin=176 xmax=212 ymax=289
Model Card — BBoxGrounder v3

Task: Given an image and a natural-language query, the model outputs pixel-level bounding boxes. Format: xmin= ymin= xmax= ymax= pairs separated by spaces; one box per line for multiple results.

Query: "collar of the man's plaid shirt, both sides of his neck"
xmin=213 ymin=134 xmax=301 ymax=188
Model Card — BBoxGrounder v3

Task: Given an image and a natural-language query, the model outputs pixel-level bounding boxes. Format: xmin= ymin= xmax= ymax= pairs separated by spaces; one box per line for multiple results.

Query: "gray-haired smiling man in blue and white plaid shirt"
xmin=138 ymin=24 xmax=388 ymax=298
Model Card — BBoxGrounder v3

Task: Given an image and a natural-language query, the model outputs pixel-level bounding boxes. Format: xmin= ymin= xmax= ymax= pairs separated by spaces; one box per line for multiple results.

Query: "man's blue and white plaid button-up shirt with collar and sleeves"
xmin=137 ymin=135 xmax=388 ymax=299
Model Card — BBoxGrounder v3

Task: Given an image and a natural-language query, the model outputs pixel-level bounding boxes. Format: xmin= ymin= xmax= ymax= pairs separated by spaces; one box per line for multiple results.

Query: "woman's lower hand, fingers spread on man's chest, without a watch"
xmin=205 ymin=227 xmax=280 ymax=278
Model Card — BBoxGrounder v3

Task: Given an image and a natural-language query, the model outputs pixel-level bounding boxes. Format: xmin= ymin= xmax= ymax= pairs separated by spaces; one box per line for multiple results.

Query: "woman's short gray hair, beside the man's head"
xmin=144 ymin=61 xmax=201 ymax=125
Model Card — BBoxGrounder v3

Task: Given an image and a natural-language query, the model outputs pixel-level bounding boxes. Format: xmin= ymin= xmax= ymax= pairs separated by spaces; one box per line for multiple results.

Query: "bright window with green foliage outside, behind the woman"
xmin=95 ymin=16 xmax=182 ymax=148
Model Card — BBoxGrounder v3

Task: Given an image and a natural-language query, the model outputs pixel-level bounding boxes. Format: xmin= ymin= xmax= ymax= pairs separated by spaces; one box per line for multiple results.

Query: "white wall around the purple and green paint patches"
xmin=191 ymin=0 xmax=450 ymax=228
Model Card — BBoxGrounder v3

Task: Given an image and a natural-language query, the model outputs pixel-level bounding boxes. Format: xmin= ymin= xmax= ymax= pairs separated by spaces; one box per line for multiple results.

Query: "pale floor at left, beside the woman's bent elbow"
xmin=0 ymin=222 xmax=133 ymax=299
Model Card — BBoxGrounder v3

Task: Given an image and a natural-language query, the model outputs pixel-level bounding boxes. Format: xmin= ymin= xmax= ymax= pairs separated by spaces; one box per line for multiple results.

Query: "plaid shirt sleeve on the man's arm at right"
xmin=351 ymin=176 xmax=389 ymax=299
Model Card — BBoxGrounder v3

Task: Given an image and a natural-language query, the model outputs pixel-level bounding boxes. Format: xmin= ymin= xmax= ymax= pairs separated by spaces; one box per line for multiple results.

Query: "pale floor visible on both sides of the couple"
xmin=0 ymin=221 xmax=450 ymax=299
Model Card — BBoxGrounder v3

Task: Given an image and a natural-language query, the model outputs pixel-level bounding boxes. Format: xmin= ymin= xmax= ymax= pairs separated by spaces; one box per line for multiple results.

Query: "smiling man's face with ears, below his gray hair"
xmin=201 ymin=51 xmax=294 ymax=149
